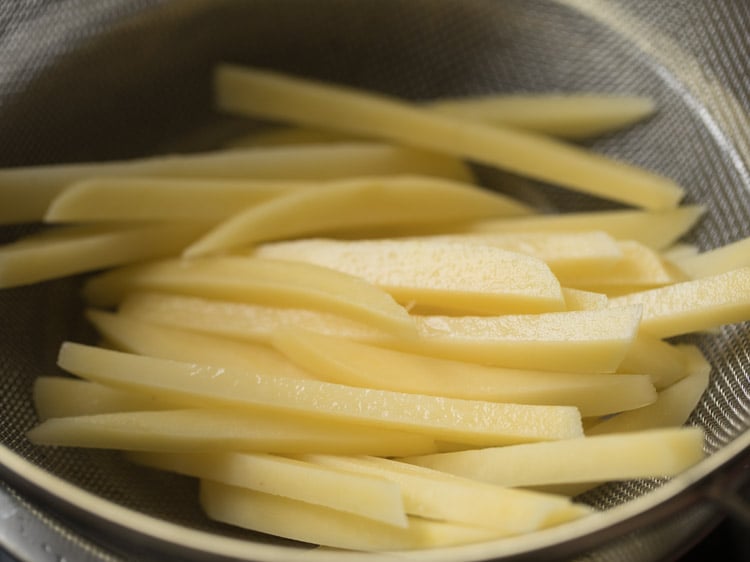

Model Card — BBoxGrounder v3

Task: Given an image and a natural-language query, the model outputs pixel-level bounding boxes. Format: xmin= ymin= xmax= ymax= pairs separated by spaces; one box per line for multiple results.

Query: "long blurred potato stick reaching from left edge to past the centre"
xmin=0 ymin=143 xmax=473 ymax=224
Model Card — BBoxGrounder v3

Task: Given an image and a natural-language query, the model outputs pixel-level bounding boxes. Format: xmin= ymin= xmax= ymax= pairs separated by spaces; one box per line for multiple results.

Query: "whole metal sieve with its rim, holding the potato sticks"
xmin=0 ymin=0 xmax=750 ymax=561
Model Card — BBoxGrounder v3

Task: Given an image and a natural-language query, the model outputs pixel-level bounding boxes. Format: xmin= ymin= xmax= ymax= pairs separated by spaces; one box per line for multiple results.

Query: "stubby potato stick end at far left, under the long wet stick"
xmin=33 ymin=376 xmax=180 ymax=421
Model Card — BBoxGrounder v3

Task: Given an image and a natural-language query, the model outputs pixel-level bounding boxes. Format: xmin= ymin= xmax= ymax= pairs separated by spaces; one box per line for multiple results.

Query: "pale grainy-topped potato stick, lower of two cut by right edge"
xmin=609 ymin=267 xmax=750 ymax=338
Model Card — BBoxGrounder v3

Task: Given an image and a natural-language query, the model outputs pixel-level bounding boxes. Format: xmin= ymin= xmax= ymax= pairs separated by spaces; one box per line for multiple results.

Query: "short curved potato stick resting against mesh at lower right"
xmin=586 ymin=345 xmax=711 ymax=435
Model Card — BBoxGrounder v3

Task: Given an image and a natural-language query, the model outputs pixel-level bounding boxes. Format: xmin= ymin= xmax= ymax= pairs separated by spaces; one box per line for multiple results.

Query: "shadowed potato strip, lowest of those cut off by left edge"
xmin=0 ymin=223 xmax=207 ymax=288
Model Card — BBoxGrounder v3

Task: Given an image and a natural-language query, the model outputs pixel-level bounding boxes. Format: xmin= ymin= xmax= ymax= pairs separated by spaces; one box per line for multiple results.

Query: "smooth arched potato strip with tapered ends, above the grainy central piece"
xmin=185 ymin=176 xmax=531 ymax=256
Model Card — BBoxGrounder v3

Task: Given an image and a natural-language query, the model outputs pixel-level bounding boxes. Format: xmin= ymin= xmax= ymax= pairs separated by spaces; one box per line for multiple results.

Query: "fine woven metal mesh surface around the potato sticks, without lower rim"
xmin=0 ymin=0 xmax=750 ymax=560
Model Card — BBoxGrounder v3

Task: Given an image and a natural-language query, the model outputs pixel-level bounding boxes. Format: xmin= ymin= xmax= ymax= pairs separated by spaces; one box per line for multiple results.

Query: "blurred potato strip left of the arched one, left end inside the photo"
xmin=44 ymin=177 xmax=306 ymax=222
